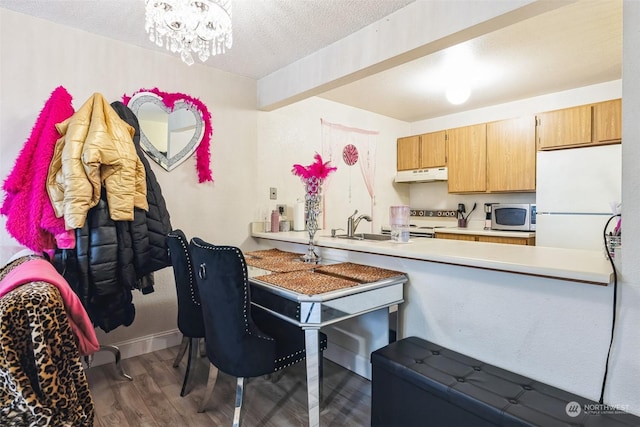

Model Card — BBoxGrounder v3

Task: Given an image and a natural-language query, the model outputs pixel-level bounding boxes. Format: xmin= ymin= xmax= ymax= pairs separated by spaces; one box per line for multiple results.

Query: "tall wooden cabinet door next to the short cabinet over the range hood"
xmin=447 ymin=123 xmax=487 ymax=193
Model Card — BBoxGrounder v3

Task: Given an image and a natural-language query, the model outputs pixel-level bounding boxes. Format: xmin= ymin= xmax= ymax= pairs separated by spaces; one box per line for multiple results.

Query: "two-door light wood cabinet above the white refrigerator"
xmin=537 ymin=99 xmax=622 ymax=150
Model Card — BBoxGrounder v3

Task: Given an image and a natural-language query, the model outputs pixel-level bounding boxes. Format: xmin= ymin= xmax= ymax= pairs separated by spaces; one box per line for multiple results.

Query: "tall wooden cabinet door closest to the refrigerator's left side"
xmin=487 ymin=116 xmax=536 ymax=192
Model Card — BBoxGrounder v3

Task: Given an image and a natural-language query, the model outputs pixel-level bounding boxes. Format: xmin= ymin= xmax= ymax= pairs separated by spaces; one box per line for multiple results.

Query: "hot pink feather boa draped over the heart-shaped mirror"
xmin=122 ymin=87 xmax=213 ymax=183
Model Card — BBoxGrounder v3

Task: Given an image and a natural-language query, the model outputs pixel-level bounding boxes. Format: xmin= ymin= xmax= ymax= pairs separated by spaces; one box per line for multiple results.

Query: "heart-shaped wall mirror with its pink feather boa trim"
xmin=126 ymin=89 xmax=212 ymax=182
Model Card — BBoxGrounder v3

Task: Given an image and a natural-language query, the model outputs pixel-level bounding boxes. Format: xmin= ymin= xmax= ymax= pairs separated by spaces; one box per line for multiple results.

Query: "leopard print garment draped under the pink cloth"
xmin=0 ymin=257 xmax=94 ymax=427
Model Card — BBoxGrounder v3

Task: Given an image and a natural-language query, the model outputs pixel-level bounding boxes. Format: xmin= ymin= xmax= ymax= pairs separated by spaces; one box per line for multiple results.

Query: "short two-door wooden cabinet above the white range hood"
xmin=397 ymin=130 xmax=447 ymax=170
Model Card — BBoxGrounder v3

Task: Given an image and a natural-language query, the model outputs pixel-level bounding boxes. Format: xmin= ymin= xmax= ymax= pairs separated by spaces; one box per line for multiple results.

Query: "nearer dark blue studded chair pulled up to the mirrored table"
xmin=189 ymin=238 xmax=327 ymax=426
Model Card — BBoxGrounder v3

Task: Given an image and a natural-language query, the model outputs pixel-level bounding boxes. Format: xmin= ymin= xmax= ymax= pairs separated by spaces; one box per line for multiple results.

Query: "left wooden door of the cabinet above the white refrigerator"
xmin=537 ymin=105 xmax=591 ymax=150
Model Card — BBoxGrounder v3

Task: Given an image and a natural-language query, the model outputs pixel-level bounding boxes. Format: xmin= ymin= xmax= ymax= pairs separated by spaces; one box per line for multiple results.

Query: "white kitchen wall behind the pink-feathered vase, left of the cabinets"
xmin=253 ymin=98 xmax=409 ymax=233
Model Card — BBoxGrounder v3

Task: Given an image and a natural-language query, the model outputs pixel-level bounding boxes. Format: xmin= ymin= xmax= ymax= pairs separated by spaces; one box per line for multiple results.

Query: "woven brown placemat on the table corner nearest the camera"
xmin=256 ymin=271 xmax=359 ymax=295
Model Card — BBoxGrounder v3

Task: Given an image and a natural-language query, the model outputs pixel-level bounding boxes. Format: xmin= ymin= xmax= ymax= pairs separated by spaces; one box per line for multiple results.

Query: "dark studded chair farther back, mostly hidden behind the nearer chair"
xmin=167 ymin=230 xmax=204 ymax=396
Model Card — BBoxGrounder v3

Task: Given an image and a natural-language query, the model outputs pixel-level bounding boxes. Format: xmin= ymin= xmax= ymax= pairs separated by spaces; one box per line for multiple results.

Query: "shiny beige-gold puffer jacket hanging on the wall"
xmin=47 ymin=93 xmax=148 ymax=230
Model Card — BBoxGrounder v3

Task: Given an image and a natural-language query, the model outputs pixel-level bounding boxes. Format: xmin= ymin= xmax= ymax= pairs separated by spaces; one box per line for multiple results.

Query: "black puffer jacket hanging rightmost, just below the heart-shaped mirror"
xmin=111 ymin=101 xmax=171 ymax=284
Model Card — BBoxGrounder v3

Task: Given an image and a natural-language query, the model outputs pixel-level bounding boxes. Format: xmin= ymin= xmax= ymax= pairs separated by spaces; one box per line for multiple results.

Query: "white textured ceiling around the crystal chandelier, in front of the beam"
xmin=0 ymin=0 xmax=414 ymax=79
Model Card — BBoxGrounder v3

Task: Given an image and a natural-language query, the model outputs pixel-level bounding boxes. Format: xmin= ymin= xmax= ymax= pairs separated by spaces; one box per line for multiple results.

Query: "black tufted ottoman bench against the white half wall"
xmin=371 ymin=337 xmax=640 ymax=427
